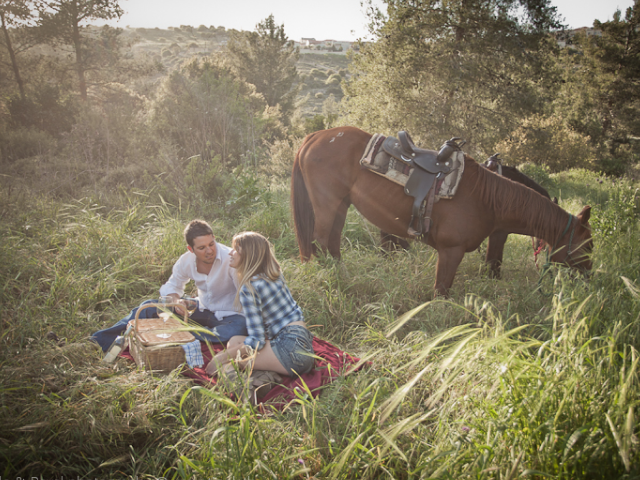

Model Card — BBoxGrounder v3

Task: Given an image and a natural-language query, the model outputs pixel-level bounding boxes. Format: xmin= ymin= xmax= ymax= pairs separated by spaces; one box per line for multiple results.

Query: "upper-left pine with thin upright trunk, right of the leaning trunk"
xmin=38 ymin=0 xmax=123 ymax=101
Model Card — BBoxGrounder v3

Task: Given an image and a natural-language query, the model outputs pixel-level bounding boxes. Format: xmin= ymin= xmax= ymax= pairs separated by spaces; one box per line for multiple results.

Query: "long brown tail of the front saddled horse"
xmin=291 ymin=142 xmax=316 ymax=262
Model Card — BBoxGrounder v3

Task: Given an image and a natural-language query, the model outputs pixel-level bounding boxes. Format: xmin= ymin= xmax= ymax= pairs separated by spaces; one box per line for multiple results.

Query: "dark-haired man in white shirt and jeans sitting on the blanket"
xmin=91 ymin=220 xmax=249 ymax=352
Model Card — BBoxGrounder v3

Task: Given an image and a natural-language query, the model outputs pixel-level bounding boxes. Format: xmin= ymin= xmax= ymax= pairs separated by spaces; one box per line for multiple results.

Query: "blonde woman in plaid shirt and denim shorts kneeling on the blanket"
xmin=206 ymin=232 xmax=314 ymax=377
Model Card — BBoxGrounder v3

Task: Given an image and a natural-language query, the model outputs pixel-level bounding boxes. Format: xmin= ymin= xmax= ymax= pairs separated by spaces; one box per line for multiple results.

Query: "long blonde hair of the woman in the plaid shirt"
xmin=231 ymin=232 xmax=281 ymax=305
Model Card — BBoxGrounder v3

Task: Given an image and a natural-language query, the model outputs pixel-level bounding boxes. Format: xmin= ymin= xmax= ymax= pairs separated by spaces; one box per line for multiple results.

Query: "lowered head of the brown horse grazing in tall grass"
xmin=551 ymin=206 xmax=593 ymax=273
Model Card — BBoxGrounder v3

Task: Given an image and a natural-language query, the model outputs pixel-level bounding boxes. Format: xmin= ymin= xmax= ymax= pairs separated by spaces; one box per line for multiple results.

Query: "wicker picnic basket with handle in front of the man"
xmin=128 ymin=303 xmax=195 ymax=373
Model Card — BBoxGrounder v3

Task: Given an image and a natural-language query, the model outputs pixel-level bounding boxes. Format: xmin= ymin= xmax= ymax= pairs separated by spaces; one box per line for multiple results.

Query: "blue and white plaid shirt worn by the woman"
xmin=240 ymin=276 xmax=304 ymax=350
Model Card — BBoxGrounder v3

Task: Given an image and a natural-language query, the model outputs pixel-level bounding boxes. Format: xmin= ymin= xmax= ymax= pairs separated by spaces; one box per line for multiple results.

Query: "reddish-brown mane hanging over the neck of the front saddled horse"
xmin=464 ymin=154 xmax=568 ymax=241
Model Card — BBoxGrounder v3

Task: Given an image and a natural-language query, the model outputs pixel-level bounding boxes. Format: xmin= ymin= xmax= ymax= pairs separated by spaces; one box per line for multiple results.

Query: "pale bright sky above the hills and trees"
xmin=102 ymin=0 xmax=634 ymax=41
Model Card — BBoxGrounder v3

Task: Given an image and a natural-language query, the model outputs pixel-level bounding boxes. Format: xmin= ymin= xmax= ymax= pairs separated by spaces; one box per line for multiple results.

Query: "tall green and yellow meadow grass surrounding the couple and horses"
xmin=0 ymin=171 xmax=640 ymax=479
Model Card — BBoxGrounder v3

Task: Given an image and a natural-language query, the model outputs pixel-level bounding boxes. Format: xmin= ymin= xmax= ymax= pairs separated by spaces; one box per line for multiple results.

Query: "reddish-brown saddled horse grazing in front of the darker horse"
xmin=291 ymin=127 xmax=593 ymax=295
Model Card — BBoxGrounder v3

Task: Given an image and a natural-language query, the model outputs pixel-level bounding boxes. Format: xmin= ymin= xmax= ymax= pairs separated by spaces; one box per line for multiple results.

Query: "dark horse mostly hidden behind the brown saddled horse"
xmin=380 ymin=154 xmax=558 ymax=278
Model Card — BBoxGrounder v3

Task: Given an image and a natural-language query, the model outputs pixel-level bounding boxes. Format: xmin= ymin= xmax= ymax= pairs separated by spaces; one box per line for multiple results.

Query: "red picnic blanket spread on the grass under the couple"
xmin=120 ymin=337 xmax=362 ymax=409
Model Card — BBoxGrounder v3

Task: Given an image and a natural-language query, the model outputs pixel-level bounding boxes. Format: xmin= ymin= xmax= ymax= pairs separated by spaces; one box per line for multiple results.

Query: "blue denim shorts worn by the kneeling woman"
xmin=271 ymin=325 xmax=315 ymax=377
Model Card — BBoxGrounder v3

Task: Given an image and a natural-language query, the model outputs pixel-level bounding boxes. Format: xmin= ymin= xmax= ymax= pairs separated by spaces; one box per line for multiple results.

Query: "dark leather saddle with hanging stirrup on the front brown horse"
xmin=382 ymin=130 xmax=465 ymax=237
